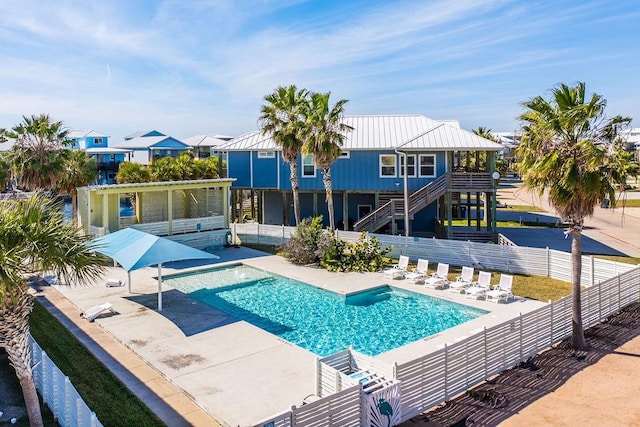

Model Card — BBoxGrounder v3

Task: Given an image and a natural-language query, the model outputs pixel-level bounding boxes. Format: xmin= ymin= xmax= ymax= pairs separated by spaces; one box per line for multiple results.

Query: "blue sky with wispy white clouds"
xmin=0 ymin=0 xmax=640 ymax=143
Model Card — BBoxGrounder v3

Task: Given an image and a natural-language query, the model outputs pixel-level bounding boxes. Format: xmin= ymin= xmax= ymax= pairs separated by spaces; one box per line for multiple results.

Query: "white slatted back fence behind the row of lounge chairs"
xmin=233 ymin=224 xmax=636 ymax=286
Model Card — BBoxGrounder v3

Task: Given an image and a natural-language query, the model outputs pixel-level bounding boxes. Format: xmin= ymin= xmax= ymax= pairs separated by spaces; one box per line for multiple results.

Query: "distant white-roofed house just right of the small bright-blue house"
xmin=114 ymin=130 xmax=191 ymax=165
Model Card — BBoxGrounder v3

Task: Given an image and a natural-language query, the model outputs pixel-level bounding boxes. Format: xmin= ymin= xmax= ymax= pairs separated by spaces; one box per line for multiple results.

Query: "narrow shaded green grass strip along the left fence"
xmin=29 ymin=301 xmax=165 ymax=426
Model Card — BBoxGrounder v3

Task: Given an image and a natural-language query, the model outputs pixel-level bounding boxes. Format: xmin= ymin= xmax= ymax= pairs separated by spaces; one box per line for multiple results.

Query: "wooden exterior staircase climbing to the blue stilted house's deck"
xmin=353 ymin=175 xmax=447 ymax=233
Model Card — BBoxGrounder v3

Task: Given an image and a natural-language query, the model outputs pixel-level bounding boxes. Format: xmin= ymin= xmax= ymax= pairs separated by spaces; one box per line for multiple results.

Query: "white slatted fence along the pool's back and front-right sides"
xmin=241 ymin=224 xmax=640 ymax=427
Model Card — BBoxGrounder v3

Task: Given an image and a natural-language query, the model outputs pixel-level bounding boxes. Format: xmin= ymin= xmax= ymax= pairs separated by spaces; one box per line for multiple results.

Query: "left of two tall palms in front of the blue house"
xmin=258 ymin=85 xmax=309 ymax=225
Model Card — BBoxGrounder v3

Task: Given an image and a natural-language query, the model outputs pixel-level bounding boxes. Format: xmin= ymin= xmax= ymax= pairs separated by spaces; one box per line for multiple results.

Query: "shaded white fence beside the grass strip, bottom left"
xmin=29 ymin=336 xmax=102 ymax=427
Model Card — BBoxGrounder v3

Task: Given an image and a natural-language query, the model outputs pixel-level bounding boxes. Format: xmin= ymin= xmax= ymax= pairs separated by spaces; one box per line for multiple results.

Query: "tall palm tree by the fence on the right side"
xmin=517 ymin=82 xmax=630 ymax=350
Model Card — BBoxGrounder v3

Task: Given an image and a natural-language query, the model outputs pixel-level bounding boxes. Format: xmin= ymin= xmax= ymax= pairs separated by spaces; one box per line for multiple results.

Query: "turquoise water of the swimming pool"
xmin=164 ymin=265 xmax=486 ymax=356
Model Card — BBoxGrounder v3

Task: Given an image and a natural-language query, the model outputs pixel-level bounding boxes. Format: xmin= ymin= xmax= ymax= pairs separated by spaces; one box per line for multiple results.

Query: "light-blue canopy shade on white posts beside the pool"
xmin=91 ymin=228 xmax=220 ymax=311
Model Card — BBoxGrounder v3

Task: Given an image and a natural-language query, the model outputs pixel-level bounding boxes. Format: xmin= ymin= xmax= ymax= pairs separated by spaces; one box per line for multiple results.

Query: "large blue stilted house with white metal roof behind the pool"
xmin=218 ymin=115 xmax=502 ymax=240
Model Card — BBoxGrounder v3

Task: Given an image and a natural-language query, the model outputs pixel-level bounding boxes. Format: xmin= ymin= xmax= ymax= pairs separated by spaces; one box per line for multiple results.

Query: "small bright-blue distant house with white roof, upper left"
xmin=68 ymin=130 xmax=131 ymax=184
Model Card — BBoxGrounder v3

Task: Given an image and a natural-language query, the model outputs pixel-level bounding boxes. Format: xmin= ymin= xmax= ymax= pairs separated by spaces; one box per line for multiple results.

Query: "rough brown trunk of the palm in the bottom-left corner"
xmin=0 ymin=288 xmax=43 ymax=427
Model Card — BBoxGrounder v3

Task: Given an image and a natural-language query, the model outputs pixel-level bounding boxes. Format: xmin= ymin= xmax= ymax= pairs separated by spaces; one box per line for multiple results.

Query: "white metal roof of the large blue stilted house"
xmin=218 ymin=114 xmax=502 ymax=151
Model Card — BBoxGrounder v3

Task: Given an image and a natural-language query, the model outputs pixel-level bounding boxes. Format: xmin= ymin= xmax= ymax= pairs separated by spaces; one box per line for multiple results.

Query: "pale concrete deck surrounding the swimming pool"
xmin=44 ymin=248 xmax=544 ymax=426
